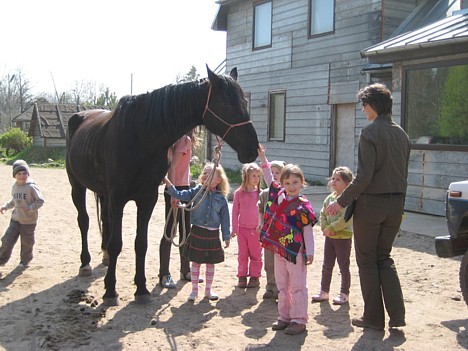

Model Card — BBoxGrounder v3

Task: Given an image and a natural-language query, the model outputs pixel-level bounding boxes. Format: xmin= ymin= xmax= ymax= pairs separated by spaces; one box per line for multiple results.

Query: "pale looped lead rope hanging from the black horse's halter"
xmin=164 ymin=146 xmax=222 ymax=247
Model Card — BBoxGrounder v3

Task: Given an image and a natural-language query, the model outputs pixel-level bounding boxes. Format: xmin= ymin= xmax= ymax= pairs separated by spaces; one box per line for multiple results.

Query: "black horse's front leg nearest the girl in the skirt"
xmin=135 ymin=189 xmax=158 ymax=304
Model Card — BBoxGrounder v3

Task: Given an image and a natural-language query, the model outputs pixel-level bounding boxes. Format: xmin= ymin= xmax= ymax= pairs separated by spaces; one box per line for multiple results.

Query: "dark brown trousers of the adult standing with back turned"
xmin=353 ymin=194 xmax=405 ymax=327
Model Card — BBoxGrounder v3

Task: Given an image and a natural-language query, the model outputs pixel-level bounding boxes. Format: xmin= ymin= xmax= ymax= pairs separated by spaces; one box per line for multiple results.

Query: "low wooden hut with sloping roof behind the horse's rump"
xmin=29 ymin=103 xmax=106 ymax=147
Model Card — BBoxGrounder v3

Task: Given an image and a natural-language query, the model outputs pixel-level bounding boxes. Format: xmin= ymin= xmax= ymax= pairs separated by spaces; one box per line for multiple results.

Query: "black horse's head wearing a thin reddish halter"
xmin=204 ymin=66 xmax=258 ymax=163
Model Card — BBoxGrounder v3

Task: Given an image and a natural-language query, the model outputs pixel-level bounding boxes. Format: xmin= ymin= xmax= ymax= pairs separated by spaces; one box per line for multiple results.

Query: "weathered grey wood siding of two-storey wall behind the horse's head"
xmin=222 ymin=0 xmax=394 ymax=183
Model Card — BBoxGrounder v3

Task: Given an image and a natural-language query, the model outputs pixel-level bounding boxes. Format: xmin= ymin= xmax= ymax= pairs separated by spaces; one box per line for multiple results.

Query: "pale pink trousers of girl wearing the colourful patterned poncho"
xmin=275 ymin=253 xmax=309 ymax=324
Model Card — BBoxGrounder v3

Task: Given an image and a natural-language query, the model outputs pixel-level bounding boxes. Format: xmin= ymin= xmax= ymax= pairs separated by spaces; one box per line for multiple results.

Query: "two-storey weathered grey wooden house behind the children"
xmin=212 ymin=0 xmax=468 ymax=215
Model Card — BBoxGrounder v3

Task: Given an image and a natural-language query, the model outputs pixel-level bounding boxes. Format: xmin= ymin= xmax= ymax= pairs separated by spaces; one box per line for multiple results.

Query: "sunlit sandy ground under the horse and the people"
xmin=0 ymin=165 xmax=468 ymax=351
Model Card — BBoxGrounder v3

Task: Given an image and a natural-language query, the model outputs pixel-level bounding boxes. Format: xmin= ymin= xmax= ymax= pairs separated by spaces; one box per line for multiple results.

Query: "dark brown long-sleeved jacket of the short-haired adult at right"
xmin=337 ymin=116 xmax=411 ymax=207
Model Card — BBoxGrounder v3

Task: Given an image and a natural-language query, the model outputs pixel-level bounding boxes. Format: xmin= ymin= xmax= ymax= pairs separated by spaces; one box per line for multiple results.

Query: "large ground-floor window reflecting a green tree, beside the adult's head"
xmin=403 ymin=62 xmax=468 ymax=150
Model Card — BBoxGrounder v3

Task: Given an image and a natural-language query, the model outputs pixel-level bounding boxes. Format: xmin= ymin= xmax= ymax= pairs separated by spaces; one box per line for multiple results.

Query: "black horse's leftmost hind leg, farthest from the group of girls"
xmin=72 ymin=182 xmax=92 ymax=277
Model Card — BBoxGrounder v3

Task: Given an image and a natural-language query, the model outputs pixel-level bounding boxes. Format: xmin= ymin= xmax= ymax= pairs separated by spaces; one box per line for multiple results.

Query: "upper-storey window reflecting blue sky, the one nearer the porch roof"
xmin=309 ymin=0 xmax=335 ymax=36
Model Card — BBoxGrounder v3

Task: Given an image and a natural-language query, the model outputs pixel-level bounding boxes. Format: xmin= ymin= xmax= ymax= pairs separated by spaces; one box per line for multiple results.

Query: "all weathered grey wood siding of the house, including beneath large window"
xmin=217 ymin=0 xmax=467 ymax=215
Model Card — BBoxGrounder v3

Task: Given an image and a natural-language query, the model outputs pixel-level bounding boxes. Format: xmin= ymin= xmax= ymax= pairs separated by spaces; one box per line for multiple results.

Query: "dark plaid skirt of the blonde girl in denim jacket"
xmin=182 ymin=225 xmax=224 ymax=263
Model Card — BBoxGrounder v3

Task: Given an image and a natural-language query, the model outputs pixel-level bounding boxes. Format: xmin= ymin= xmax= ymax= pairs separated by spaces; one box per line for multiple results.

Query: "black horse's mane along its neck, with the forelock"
xmin=114 ymin=75 xmax=249 ymax=128
